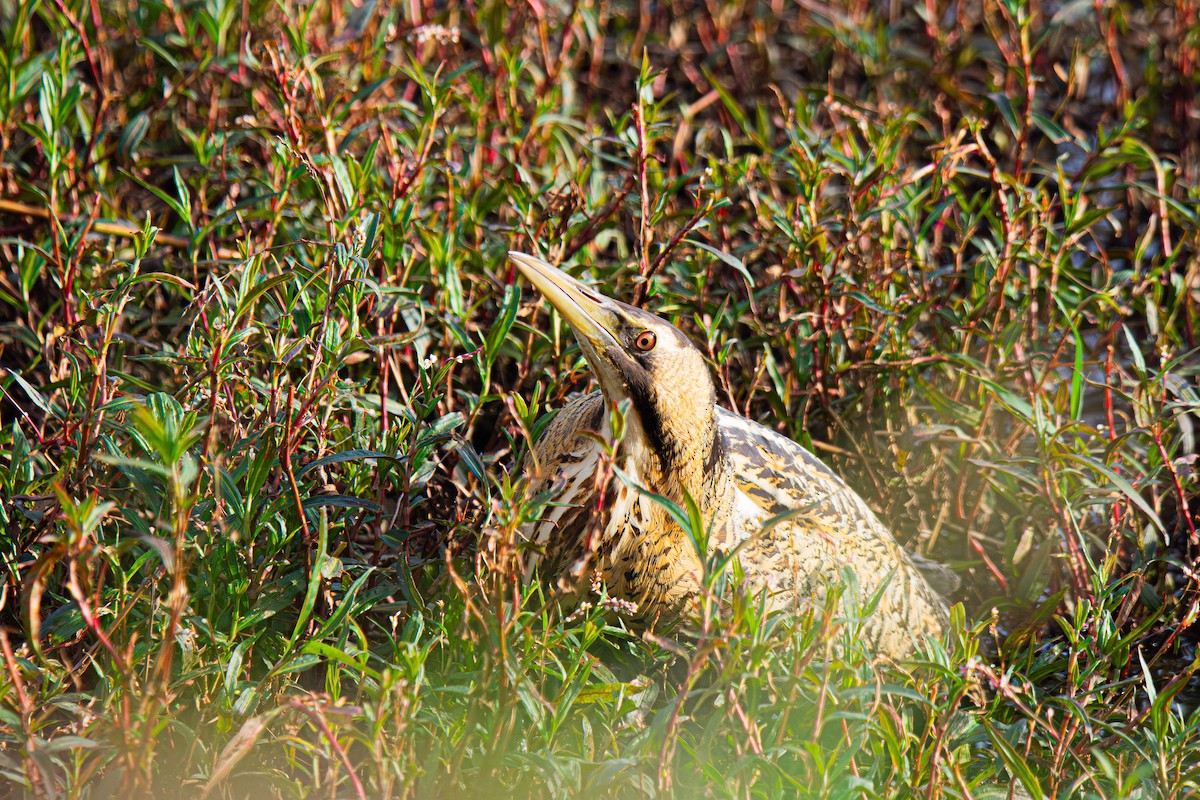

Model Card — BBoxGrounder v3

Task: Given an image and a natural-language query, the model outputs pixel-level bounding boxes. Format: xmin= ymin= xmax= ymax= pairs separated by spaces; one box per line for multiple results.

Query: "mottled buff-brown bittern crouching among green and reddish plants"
xmin=509 ymin=251 xmax=949 ymax=658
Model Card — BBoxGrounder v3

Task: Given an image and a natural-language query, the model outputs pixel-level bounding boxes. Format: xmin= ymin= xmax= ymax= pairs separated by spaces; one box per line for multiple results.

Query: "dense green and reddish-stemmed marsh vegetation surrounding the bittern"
xmin=0 ymin=0 xmax=1200 ymax=798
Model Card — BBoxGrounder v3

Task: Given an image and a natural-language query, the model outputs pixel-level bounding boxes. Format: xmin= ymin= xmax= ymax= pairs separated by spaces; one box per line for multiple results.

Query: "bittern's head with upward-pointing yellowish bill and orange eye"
xmin=509 ymin=252 xmax=716 ymax=468
